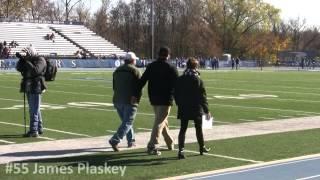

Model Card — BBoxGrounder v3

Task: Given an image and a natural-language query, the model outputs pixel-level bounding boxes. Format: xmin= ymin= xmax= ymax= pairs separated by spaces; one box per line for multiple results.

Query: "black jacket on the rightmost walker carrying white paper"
xmin=174 ymin=71 xmax=209 ymax=120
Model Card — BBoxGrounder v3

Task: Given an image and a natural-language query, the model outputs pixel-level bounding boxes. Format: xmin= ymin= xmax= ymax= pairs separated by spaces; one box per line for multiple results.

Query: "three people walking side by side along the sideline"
xmin=109 ymin=47 xmax=211 ymax=159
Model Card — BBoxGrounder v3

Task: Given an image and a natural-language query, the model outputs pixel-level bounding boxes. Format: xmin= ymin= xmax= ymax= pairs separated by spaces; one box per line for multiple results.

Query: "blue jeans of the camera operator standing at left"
xmin=27 ymin=93 xmax=43 ymax=132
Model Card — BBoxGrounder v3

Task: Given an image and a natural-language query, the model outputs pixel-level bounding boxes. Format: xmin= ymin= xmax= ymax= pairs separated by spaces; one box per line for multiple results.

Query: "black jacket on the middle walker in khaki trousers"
xmin=139 ymin=59 xmax=178 ymax=106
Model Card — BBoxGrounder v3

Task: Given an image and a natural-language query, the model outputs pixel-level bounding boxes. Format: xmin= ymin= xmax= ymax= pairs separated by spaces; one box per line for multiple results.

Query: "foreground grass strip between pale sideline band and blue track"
xmin=0 ymin=129 xmax=320 ymax=180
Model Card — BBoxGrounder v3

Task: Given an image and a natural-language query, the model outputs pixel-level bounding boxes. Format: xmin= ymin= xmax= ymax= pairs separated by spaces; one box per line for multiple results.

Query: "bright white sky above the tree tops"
xmin=65 ymin=0 xmax=320 ymax=27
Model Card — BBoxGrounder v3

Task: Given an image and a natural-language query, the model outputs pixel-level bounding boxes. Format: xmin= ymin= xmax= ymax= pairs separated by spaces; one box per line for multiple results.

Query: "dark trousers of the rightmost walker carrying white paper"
xmin=179 ymin=118 xmax=204 ymax=151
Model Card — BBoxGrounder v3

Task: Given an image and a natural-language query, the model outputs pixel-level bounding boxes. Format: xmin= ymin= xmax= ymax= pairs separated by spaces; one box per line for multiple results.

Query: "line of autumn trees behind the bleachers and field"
xmin=0 ymin=0 xmax=320 ymax=61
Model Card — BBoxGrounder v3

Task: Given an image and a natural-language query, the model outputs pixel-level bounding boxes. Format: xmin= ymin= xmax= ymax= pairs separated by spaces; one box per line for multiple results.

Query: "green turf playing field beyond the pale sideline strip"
xmin=0 ymin=70 xmax=320 ymax=145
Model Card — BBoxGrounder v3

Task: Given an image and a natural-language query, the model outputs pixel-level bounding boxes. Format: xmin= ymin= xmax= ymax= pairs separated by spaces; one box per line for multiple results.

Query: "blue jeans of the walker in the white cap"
xmin=111 ymin=103 xmax=137 ymax=144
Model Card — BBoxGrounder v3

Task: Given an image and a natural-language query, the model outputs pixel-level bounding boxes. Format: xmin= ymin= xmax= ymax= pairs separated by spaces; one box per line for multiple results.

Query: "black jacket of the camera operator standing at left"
xmin=16 ymin=56 xmax=47 ymax=94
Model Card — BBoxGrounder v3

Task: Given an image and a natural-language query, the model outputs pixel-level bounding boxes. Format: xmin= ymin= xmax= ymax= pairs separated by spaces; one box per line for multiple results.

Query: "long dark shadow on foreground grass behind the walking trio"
xmin=23 ymin=151 xmax=177 ymax=167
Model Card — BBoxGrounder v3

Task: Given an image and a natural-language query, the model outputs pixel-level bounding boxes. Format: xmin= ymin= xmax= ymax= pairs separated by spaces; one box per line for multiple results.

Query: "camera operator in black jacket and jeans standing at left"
xmin=16 ymin=47 xmax=47 ymax=137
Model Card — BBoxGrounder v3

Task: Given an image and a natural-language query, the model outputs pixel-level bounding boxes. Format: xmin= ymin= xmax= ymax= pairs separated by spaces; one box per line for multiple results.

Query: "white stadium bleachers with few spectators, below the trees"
xmin=0 ymin=22 xmax=125 ymax=57
